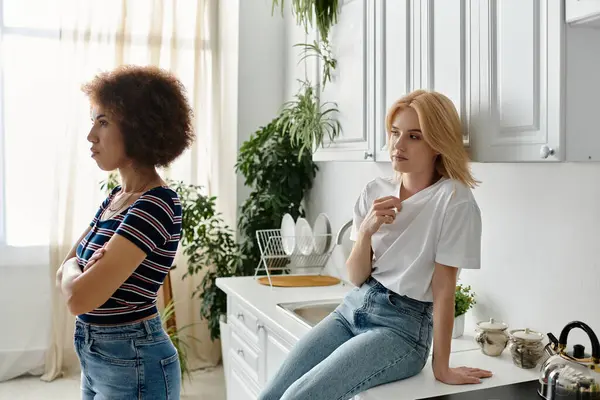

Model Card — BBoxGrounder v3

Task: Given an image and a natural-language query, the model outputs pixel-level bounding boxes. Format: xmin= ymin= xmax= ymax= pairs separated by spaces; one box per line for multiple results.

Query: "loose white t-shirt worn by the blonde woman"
xmin=350 ymin=178 xmax=481 ymax=301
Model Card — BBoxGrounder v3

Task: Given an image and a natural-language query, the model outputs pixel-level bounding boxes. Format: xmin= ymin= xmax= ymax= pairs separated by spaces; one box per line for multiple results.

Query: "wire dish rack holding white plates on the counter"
xmin=254 ymin=229 xmax=335 ymax=282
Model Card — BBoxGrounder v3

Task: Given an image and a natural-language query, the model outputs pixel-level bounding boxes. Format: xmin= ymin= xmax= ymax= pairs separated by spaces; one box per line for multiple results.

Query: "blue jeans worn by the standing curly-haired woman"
xmin=75 ymin=316 xmax=181 ymax=400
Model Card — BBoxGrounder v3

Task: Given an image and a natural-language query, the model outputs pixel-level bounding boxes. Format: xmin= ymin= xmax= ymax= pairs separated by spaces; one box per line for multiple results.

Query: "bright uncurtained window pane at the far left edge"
xmin=0 ymin=0 xmax=61 ymax=246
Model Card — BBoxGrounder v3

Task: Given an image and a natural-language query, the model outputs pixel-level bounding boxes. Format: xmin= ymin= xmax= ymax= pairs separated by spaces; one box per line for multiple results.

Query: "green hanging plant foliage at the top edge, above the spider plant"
xmin=271 ymin=0 xmax=339 ymax=42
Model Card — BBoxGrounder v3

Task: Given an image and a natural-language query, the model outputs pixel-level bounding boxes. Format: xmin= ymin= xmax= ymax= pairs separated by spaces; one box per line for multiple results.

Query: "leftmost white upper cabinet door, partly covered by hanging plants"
xmin=313 ymin=0 xmax=375 ymax=161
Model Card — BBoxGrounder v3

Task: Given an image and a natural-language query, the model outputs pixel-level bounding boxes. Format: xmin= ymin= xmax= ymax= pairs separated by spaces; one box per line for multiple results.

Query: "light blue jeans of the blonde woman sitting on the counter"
xmin=259 ymin=278 xmax=433 ymax=400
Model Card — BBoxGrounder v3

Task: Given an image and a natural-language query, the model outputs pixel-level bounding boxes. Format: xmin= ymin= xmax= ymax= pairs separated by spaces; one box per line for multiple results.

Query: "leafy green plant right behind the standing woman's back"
xmin=101 ymin=173 xmax=243 ymax=340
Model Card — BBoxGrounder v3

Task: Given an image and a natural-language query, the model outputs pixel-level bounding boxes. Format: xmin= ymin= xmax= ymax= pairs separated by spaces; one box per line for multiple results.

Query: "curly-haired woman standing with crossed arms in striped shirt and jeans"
xmin=56 ymin=66 xmax=194 ymax=399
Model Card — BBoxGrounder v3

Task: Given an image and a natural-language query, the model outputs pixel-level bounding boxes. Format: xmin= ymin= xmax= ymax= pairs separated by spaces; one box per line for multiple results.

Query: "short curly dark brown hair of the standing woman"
xmin=82 ymin=65 xmax=195 ymax=167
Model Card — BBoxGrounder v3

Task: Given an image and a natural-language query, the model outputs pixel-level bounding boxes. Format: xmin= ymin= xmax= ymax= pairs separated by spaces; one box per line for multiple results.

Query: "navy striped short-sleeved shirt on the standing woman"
xmin=77 ymin=186 xmax=181 ymax=324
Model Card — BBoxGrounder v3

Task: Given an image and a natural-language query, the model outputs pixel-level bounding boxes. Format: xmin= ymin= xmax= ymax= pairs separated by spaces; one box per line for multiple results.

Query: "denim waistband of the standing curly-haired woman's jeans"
xmin=75 ymin=315 xmax=163 ymax=340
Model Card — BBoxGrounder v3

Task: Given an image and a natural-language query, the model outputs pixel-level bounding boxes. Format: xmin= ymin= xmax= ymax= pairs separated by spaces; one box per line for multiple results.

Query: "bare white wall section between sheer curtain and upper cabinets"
xmin=214 ymin=0 xmax=285 ymax=227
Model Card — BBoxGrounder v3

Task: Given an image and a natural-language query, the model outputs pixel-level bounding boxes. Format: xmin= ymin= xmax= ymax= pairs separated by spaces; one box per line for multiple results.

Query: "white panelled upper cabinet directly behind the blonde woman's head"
xmin=376 ymin=0 xmax=565 ymax=162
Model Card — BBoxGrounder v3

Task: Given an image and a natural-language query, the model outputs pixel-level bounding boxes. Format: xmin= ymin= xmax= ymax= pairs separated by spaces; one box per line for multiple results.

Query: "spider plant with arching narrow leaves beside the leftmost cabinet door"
xmin=277 ymin=84 xmax=342 ymax=159
